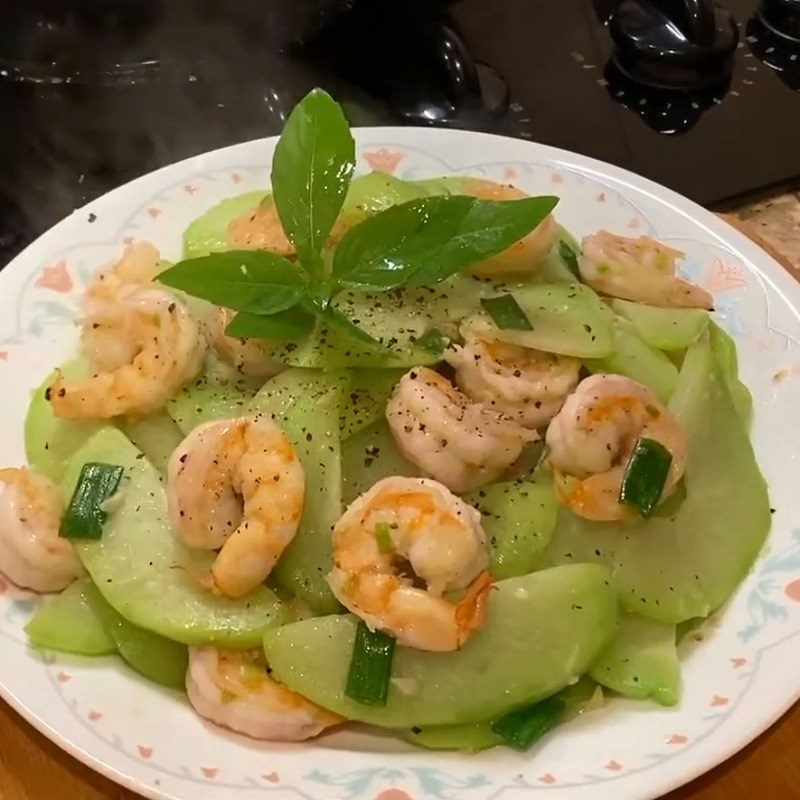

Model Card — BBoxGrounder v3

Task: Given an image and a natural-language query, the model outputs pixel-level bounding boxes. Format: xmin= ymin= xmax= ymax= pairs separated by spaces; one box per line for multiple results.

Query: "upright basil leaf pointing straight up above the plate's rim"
xmin=272 ymin=89 xmax=356 ymax=268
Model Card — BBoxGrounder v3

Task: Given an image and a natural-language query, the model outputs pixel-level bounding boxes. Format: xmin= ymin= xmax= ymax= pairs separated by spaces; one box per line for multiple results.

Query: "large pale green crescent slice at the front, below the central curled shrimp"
xmin=264 ymin=564 xmax=617 ymax=728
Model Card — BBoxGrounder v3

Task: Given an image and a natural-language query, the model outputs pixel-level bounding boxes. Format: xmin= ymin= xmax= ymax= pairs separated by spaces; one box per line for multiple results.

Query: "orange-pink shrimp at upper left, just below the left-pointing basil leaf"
xmin=48 ymin=243 xmax=206 ymax=419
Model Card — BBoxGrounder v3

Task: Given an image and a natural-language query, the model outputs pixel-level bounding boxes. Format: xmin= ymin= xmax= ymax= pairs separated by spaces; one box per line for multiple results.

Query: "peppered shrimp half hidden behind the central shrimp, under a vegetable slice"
xmin=445 ymin=338 xmax=580 ymax=429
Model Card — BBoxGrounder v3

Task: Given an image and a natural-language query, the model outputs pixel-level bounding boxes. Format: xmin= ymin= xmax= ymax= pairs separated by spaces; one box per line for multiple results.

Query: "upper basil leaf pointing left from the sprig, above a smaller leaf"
xmin=156 ymin=250 xmax=305 ymax=314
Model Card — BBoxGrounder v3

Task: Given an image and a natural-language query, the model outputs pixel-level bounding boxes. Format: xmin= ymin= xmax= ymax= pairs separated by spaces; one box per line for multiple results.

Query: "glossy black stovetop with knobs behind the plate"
xmin=0 ymin=0 xmax=800 ymax=265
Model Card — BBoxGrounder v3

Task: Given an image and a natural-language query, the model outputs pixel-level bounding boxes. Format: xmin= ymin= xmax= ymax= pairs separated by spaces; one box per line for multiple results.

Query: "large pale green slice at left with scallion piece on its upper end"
xmin=62 ymin=427 xmax=288 ymax=648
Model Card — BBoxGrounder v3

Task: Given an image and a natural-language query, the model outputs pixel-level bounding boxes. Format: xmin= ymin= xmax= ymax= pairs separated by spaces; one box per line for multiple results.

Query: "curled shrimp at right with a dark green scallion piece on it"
xmin=547 ymin=375 xmax=687 ymax=521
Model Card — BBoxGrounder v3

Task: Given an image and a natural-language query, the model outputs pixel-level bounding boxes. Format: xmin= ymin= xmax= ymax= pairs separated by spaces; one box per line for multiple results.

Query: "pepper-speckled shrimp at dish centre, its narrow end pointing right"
xmin=386 ymin=367 xmax=537 ymax=492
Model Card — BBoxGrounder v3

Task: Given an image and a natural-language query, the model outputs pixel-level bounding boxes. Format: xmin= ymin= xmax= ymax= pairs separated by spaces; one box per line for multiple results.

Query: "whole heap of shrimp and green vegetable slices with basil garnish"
xmin=12 ymin=91 xmax=770 ymax=750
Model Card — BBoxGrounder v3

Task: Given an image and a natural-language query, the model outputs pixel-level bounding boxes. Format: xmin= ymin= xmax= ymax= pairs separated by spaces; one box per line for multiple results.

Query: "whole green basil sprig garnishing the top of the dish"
xmin=158 ymin=89 xmax=558 ymax=347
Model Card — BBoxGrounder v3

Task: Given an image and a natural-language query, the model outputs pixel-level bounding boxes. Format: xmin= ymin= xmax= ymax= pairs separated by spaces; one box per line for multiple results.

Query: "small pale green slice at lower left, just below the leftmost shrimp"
xmin=25 ymin=578 xmax=117 ymax=656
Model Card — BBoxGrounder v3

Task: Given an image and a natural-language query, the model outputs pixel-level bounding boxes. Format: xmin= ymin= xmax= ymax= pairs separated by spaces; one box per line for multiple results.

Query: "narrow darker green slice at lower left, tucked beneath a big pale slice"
xmin=87 ymin=582 xmax=189 ymax=690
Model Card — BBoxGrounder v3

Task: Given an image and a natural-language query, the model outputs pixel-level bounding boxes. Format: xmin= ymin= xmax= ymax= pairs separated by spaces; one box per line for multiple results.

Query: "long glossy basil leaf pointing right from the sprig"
xmin=333 ymin=195 xmax=558 ymax=290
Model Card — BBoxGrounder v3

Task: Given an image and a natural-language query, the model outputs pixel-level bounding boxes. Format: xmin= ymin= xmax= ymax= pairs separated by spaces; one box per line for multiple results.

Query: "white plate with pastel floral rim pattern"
xmin=0 ymin=128 xmax=800 ymax=800
